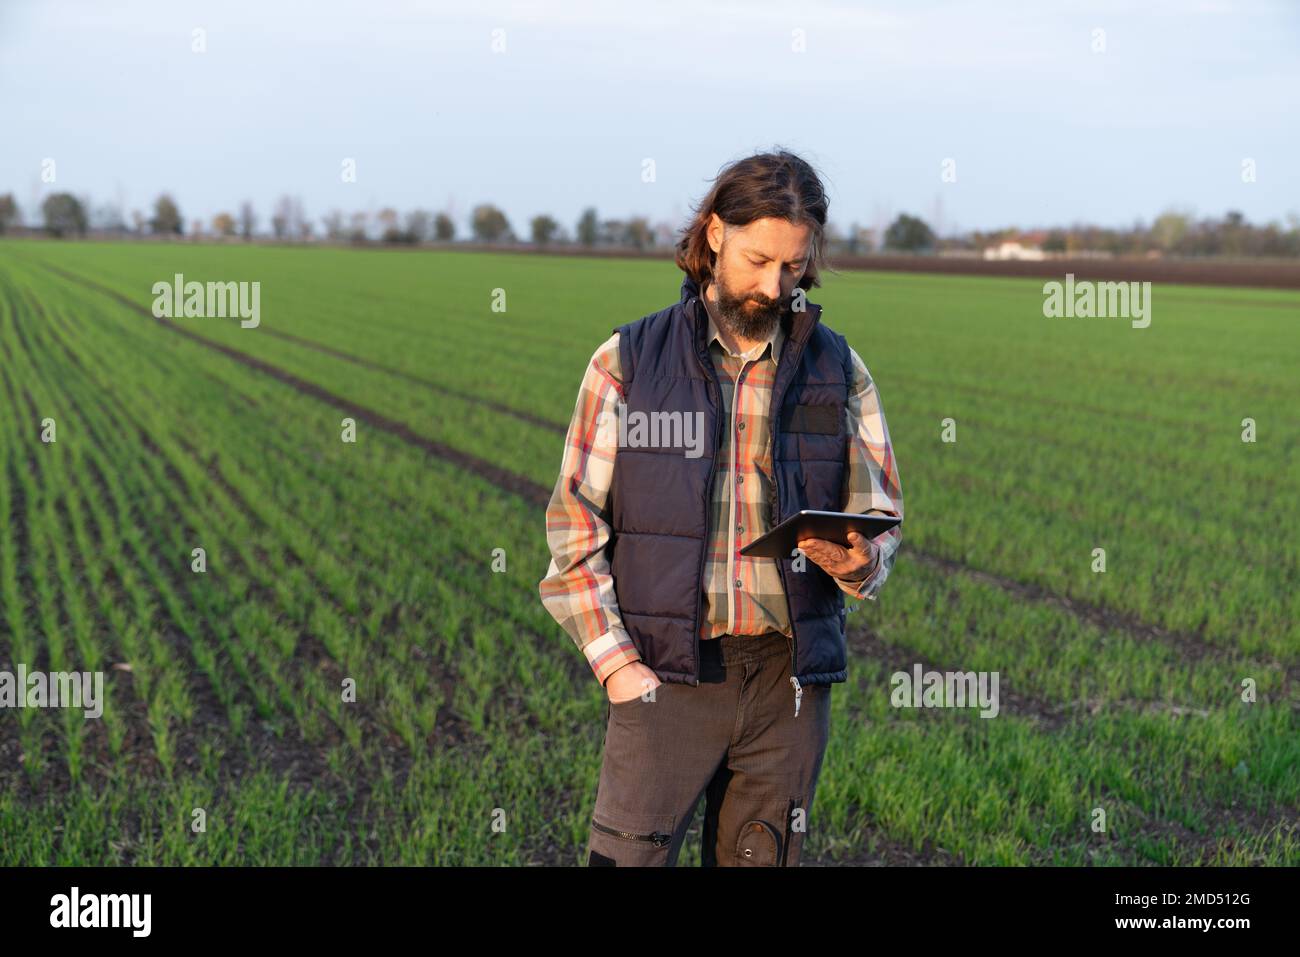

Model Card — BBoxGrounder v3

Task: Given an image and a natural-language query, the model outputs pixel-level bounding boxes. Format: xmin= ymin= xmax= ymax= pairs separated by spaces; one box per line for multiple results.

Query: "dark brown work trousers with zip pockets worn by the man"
xmin=588 ymin=632 xmax=831 ymax=867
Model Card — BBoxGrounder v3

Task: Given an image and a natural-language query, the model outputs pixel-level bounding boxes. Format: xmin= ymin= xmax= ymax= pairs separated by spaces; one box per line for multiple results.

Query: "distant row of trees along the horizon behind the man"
xmin=0 ymin=192 xmax=1300 ymax=257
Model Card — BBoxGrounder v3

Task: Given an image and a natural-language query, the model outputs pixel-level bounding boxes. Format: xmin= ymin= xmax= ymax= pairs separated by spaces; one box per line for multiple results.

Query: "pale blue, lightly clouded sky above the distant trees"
xmin=0 ymin=0 xmax=1300 ymax=234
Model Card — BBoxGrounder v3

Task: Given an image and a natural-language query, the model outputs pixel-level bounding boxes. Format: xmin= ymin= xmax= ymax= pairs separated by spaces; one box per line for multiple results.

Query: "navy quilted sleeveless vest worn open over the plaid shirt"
xmin=610 ymin=277 xmax=853 ymax=685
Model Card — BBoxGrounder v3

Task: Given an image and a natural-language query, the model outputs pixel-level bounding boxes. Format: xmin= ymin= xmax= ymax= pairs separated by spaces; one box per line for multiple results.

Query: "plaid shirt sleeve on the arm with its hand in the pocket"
xmin=538 ymin=333 xmax=641 ymax=687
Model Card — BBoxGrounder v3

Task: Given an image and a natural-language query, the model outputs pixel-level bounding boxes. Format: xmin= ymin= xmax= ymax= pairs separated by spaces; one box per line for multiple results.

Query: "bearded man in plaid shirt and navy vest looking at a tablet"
xmin=540 ymin=151 xmax=902 ymax=866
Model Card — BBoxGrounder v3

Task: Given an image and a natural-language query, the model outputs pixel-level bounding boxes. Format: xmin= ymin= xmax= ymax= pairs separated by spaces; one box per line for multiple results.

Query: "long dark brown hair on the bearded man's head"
xmin=677 ymin=148 xmax=827 ymax=289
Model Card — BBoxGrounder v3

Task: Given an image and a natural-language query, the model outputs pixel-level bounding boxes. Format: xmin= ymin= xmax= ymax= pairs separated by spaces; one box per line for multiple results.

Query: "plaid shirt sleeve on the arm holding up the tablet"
xmin=836 ymin=348 xmax=902 ymax=601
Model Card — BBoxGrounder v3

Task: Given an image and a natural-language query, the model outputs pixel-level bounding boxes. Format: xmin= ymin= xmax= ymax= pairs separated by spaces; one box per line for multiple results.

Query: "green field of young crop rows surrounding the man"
xmin=0 ymin=242 xmax=1300 ymax=865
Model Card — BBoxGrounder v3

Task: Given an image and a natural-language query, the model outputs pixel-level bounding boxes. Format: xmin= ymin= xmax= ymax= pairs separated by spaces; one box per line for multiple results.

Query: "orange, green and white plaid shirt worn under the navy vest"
xmin=538 ymin=302 xmax=902 ymax=687
